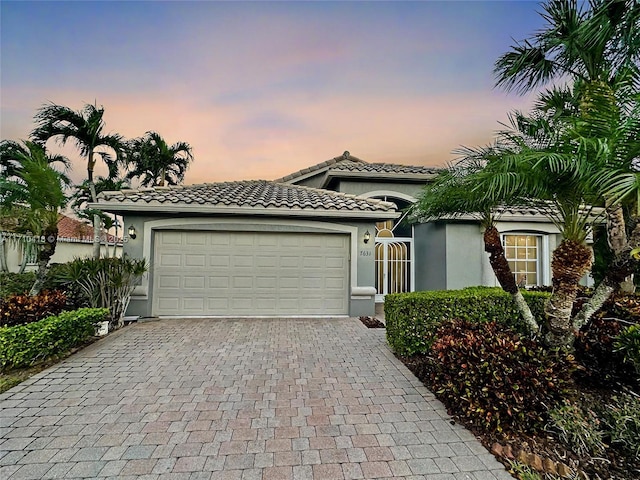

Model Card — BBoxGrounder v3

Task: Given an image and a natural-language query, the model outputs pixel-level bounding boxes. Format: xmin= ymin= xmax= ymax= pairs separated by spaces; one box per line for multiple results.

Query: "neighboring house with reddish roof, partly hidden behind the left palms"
xmin=0 ymin=214 xmax=122 ymax=272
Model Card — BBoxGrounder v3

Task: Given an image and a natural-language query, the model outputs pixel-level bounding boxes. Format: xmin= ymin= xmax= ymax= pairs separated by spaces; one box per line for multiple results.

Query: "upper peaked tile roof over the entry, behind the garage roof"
xmin=276 ymin=152 xmax=440 ymax=182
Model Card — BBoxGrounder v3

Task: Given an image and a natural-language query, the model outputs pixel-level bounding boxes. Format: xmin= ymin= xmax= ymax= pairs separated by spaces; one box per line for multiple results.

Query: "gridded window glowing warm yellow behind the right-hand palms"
xmin=503 ymin=235 xmax=542 ymax=287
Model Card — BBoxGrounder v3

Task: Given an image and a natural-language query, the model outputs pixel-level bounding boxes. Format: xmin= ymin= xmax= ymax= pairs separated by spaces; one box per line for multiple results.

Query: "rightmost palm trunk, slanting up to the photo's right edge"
xmin=573 ymin=222 xmax=640 ymax=330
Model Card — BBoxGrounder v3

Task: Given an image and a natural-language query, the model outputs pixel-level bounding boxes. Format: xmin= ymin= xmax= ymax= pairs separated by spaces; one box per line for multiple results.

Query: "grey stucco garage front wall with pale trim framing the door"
xmin=124 ymin=216 xmax=375 ymax=316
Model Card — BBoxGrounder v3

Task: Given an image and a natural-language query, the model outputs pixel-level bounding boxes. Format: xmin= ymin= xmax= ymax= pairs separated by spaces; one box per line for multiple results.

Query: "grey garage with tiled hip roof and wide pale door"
xmin=92 ymin=180 xmax=400 ymax=317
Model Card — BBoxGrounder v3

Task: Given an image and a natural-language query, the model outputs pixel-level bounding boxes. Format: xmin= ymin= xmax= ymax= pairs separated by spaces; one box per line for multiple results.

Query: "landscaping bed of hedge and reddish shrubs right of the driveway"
xmin=385 ymin=289 xmax=640 ymax=480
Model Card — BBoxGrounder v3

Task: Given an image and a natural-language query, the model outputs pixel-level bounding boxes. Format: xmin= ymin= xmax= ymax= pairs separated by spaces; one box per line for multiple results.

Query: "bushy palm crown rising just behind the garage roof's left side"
xmin=127 ymin=132 xmax=193 ymax=186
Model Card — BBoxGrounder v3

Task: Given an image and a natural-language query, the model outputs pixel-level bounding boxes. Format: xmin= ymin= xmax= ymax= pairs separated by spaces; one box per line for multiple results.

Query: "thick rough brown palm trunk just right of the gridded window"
xmin=544 ymin=239 xmax=592 ymax=348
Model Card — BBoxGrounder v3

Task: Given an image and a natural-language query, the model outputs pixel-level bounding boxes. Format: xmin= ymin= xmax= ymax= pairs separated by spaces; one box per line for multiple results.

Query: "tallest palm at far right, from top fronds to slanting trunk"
xmin=495 ymin=0 xmax=640 ymax=344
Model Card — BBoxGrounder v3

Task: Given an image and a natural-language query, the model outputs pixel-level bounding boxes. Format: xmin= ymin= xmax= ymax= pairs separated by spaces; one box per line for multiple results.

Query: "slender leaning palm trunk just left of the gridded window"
xmin=484 ymin=226 xmax=540 ymax=335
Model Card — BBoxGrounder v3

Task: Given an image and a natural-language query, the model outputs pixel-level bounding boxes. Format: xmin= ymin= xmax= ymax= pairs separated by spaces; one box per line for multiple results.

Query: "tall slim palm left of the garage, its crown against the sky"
xmin=31 ymin=103 xmax=123 ymax=258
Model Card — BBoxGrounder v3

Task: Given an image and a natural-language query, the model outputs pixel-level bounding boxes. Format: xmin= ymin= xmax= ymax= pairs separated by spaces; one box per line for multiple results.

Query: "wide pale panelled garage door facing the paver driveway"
xmin=153 ymin=231 xmax=349 ymax=316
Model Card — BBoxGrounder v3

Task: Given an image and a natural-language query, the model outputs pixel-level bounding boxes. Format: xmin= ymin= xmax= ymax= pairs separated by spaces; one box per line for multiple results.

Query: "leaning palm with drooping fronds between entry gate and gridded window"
xmin=412 ymin=152 xmax=539 ymax=336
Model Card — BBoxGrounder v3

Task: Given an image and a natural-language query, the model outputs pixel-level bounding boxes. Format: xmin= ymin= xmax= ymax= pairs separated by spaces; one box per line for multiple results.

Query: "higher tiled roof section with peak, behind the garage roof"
xmin=276 ymin=152 xmax=440 ymax=186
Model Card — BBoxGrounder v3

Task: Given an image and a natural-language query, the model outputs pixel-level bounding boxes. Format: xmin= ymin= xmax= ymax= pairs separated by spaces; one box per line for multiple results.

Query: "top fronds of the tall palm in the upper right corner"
xmin=495 ymin=0 xmax=640 ymax=95
